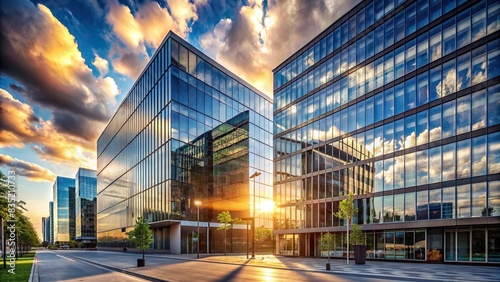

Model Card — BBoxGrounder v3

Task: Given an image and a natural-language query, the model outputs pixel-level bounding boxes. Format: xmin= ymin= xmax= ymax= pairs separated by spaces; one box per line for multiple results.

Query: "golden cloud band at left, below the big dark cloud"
xmin=0 ymin=89 xmax=97 ymax=168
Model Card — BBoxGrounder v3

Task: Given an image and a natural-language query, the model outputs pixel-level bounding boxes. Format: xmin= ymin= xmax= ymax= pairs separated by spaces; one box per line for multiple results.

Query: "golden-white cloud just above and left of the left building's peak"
xmin=106 ymin=0 xmax=200 ymax=79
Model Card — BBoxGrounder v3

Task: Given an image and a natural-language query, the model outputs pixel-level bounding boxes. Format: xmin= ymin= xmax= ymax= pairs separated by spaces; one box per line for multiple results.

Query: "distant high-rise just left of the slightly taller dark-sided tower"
xmin=51 ymin=176 xmax=75 ymax=245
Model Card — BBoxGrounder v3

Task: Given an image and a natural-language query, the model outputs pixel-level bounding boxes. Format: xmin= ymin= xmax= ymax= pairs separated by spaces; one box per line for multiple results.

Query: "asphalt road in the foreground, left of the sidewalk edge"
xmin=38 ymin=250 xmax=394 ymax=282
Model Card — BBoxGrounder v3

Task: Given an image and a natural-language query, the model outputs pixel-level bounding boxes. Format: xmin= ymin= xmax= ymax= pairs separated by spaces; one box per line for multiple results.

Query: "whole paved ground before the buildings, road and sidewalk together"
xmin=33 ymin=251 xmax=500 ymax=282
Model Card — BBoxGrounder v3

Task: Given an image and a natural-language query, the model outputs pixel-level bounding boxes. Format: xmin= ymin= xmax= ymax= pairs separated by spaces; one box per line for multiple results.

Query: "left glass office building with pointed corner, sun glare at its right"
xmin=97 ymin=32 xmax=273 ymax=253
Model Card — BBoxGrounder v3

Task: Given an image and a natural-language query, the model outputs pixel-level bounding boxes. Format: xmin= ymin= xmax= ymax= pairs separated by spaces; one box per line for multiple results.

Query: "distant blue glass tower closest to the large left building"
xmin=75 ymin=168 xmax=97 ymax=245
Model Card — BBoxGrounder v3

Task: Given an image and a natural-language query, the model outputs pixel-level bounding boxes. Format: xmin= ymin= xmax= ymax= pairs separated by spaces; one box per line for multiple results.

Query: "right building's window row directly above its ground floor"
xmin=275 ymin=180 xmax=500 ymax=229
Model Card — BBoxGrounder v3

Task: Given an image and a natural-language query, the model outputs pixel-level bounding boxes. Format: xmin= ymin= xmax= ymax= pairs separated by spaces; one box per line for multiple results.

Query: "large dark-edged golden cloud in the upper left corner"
xmin=0 ymin=1 xmax=118 ymax=140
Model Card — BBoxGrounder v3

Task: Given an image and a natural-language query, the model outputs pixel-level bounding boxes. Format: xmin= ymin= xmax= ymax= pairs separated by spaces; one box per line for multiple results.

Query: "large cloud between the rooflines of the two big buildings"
xmin=200 ymin=0 xmax=359 ymax=95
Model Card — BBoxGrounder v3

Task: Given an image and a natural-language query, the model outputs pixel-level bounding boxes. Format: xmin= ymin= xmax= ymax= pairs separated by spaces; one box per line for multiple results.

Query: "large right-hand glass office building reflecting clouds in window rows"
xmin=274 ymin=0 xmax=500 ymax=263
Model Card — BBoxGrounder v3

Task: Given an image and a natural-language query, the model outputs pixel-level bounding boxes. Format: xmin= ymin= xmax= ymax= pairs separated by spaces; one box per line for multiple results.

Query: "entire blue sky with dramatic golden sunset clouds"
xmin=0 ymin=0 xmax=359 ymax=241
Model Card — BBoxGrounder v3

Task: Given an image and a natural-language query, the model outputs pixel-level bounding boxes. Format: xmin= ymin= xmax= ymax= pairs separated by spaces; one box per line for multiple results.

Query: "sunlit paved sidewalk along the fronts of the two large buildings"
xmin=147 ymin=254 xmax=500 ymax=281
